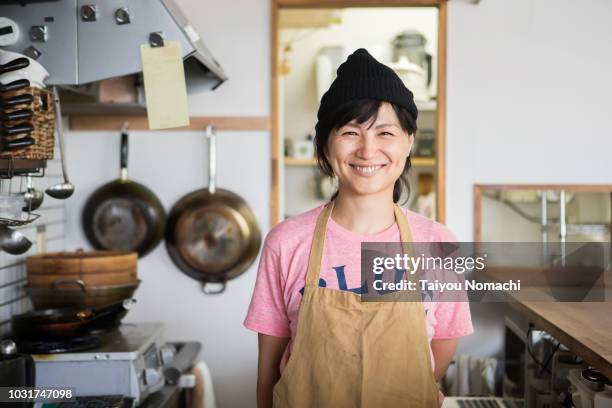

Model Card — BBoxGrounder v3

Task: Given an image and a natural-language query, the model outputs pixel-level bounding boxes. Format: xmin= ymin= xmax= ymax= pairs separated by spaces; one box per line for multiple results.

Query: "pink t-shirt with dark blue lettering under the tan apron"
xmin=244 ymin=206 xmax=473 ymax=370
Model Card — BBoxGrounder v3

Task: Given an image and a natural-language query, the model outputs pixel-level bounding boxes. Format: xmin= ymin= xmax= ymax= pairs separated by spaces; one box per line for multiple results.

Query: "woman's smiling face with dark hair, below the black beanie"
xmin=315 ymin=99 xmax=416 ymax=202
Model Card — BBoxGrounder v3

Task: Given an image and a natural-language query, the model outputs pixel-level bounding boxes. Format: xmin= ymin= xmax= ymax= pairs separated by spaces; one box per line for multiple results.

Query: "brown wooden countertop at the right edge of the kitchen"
xmin=511 ymin=301 xmax=612 ymax=379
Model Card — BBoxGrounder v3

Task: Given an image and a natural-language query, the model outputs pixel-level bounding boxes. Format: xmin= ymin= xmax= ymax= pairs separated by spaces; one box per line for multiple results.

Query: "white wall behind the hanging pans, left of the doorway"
xmin=66 ymin=0 xmax=270 ymax=408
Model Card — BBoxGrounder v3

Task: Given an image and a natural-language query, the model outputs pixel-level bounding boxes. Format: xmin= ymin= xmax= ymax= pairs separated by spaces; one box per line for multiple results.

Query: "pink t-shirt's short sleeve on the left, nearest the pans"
xmin=244 ymin=245 xmax=291 ymax=337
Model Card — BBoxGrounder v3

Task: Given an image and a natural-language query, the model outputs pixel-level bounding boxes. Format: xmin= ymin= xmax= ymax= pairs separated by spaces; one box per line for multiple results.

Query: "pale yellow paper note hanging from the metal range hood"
xmin=140 ymin=41 xmax=189 ymax=130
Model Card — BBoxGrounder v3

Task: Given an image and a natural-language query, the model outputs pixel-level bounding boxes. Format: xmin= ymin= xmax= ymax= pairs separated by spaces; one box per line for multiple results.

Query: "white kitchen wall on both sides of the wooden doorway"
xmin=61 ymin=0 xmax=612 ymax=408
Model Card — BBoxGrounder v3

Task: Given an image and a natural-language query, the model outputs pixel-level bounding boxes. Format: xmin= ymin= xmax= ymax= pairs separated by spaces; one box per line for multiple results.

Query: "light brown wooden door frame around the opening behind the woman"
xmin=270 ymin=0 xmax=448 ymax=227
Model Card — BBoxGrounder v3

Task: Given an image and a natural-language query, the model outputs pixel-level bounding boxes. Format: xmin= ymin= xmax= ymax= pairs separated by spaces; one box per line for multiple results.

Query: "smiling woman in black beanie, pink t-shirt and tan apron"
xmin=245 ymin=49 xmax=472 ymax=408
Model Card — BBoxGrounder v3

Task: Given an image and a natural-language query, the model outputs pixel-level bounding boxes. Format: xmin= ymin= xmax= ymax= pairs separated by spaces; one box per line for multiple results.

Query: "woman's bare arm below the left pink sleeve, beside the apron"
xmin=257 ymin=333 xmax=289 ymax=408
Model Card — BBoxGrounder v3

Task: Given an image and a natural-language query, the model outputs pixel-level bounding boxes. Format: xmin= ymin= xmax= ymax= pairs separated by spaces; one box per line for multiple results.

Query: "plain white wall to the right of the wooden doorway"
xmin=446 ymin=0 xmax=612 ymax=355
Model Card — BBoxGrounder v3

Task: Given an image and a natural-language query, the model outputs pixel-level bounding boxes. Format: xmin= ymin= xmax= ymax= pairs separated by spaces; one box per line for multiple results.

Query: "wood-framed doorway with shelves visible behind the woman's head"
xmin=271 ymin=0 xmax=446 ymax=226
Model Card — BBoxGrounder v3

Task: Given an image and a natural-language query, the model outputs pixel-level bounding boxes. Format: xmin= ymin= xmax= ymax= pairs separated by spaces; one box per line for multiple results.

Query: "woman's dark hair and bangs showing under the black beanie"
xmin=314 ymin=99 xmax=417 ymax=203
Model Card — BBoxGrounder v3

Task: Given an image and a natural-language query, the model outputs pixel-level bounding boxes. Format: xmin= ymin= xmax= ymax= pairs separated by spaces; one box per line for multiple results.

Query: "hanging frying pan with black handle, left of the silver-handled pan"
xmin=83 ymin=126 xmax=166 ymax=256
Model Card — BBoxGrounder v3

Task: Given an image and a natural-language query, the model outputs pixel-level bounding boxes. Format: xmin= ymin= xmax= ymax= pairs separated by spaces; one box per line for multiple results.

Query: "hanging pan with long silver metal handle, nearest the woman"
xmin=166 ymin=124 xmax=261 ymax=294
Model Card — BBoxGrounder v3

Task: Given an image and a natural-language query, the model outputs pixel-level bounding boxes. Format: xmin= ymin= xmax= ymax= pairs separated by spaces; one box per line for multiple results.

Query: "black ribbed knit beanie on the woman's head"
xmin=317 ymin=48 xmax=418 ymax=121
